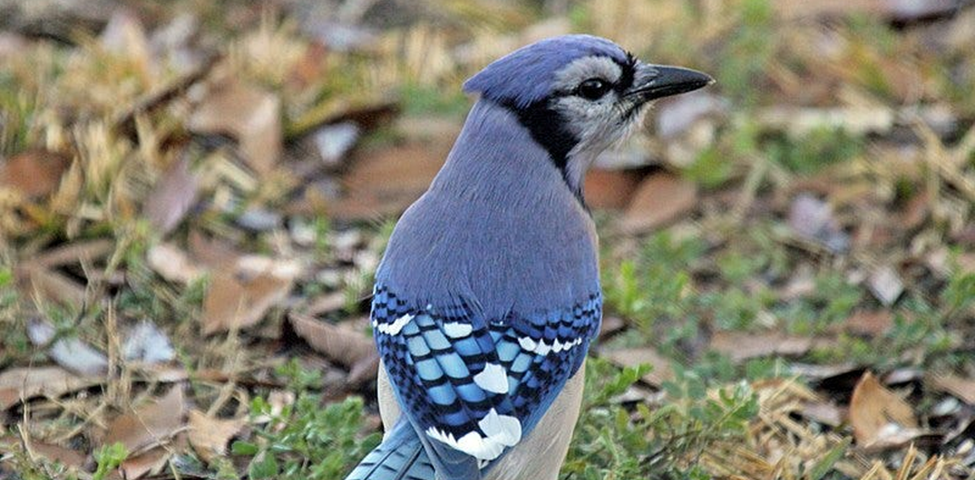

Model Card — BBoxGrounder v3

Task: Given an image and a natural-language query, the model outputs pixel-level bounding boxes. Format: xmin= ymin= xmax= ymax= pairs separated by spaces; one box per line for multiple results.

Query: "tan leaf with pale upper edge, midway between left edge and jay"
xmin=202 ymin=257 xmax=298 ymax=335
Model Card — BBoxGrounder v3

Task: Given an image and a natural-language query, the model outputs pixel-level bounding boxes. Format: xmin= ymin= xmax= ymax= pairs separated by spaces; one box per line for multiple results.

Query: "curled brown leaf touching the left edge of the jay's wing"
xmin=288 ymin=312 xmax=376 ymax=368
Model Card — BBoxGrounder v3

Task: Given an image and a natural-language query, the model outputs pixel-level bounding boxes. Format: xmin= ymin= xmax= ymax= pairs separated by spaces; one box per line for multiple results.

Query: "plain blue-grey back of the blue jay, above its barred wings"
xmin=377 ymin=101 xmax=599 ymax=321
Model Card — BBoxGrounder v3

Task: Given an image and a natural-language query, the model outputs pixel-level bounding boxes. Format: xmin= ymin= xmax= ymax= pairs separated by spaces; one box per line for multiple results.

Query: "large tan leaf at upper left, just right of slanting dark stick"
xmin=189 ymin=79 xmax=283 ymax=175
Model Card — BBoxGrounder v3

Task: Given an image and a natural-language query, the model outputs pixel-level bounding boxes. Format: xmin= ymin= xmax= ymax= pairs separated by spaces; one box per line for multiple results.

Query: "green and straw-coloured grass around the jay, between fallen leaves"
xmin=0 ymin=0 xmax=975 ymax=480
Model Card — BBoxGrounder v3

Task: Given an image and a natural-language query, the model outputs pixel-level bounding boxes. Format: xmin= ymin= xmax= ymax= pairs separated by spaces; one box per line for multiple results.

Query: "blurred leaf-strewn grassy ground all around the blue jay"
xmin=0 ymin=0 xmax=975 ymax=480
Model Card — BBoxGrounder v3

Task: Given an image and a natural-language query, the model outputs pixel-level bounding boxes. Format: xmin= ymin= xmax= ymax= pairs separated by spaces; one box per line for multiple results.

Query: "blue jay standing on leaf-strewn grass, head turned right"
xmin=346 ymin=34 xmax=714 ymax=480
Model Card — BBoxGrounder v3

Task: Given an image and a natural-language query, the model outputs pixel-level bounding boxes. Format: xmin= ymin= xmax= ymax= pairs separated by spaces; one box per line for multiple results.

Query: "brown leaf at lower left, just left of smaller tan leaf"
xmin=99 ymin=385 xmax=187 ymax=453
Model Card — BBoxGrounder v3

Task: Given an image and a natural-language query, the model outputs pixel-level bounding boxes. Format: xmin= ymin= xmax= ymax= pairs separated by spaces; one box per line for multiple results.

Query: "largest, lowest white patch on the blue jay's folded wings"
xmin=426 ymin=408 xmax=521 ymax=465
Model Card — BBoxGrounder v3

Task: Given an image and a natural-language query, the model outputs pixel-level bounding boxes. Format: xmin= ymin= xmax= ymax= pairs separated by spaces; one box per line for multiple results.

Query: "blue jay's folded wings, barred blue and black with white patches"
xmin=372 ymin=284 xmax=601 ymax=479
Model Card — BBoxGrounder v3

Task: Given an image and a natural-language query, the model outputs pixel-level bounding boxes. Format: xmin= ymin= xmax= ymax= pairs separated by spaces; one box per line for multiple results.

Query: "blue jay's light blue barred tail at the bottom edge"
xmin=345 ymin=416 xmax=434 ymax=480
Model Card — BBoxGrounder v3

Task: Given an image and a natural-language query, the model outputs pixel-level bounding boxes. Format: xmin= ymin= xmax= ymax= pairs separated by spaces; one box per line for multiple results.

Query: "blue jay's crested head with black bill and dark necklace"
xmin=464 ymin=35 xmax=714 ymax=195
